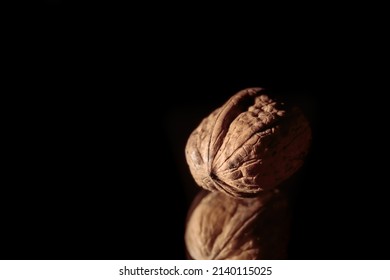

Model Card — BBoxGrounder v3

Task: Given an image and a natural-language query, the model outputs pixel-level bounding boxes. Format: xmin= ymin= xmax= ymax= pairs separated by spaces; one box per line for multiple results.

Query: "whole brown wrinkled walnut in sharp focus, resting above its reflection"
xmin=185 ymin=88 xmax=311 ymax=197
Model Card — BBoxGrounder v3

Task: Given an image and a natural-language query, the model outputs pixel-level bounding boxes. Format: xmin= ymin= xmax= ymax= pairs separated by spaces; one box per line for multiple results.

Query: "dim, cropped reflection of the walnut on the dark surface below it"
xmin=185 ymin=190 xmax=290 ymax=260
